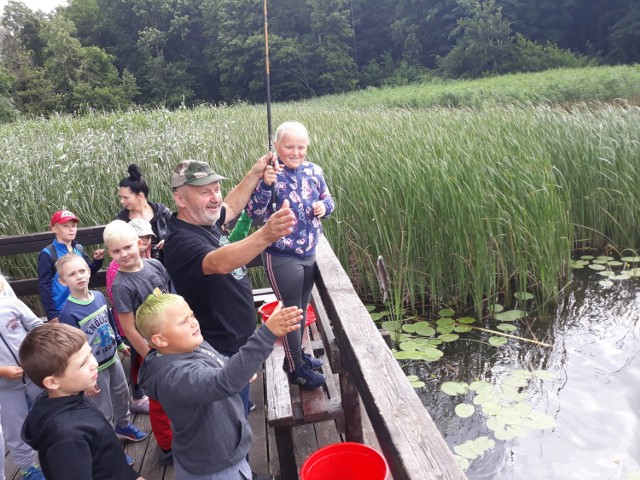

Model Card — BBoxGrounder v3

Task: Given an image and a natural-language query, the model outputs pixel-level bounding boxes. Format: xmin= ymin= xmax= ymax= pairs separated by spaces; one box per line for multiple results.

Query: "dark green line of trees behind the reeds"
xmin=0 ymin=0 xmax=640 ymax=120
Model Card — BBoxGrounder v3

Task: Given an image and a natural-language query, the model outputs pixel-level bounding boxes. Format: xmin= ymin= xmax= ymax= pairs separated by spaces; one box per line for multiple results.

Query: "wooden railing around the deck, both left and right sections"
xmin=0 ymin=226 xmax=466 ymax=480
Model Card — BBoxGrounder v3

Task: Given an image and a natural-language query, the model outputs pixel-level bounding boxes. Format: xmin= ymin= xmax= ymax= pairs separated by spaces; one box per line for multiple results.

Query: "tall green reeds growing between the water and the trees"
xmin=0 ymin=66 xmax=640 ymax=316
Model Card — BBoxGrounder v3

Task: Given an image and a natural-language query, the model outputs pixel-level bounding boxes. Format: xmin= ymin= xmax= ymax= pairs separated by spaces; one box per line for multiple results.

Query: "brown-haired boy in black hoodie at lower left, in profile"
xmin=19 ymin=323 xmax=144 ymax=480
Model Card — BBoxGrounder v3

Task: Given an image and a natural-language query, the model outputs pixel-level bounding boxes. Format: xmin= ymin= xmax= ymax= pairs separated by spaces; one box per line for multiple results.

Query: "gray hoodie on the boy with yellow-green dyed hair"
xmin=139 ymin=325 xmax=276 ymax=474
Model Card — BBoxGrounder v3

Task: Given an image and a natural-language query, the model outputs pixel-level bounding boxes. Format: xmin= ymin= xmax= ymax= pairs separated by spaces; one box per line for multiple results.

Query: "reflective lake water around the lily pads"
xmin=405 ymin=269 xmax=640 ymax=480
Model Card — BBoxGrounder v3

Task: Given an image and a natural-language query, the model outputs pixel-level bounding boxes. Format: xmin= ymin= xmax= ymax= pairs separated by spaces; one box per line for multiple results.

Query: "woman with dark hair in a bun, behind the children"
xmin=116 ymin=163 xmax=171 ymax=263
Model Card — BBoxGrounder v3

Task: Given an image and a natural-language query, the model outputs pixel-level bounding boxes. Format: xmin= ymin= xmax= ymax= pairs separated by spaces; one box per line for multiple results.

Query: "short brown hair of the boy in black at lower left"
xmin=18 ymin=323 xmax=87 ymax=388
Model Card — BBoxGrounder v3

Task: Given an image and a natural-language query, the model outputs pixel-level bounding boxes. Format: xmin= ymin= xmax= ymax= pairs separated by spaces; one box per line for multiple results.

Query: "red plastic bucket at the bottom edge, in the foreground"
xmin=300 ymin=442 xmax=389 ymax=480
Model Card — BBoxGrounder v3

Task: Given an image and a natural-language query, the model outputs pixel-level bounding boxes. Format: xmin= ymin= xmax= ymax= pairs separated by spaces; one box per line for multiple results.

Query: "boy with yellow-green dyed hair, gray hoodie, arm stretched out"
xmin=136 ymin=294 xmax=302 ymax=480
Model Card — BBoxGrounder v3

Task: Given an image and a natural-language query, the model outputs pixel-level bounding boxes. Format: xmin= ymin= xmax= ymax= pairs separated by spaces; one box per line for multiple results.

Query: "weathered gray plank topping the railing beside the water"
xmin=316 ymin=238 xmax=465 ymax=480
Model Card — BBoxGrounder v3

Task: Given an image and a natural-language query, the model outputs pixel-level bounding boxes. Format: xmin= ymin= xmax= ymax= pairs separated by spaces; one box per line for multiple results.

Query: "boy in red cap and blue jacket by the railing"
xmin=38 ymin=210 xmax=104 ymax=322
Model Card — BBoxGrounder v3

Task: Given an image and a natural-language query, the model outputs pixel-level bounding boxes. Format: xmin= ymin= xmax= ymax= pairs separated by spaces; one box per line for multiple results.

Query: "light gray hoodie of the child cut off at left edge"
xmin=0 ymin=296 xmax=42 ymax=390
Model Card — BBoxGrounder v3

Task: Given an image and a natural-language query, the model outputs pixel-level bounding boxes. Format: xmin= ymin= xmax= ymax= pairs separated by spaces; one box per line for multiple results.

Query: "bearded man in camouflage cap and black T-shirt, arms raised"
xmin=164 ymin=153 xmax=296 ymax=422
